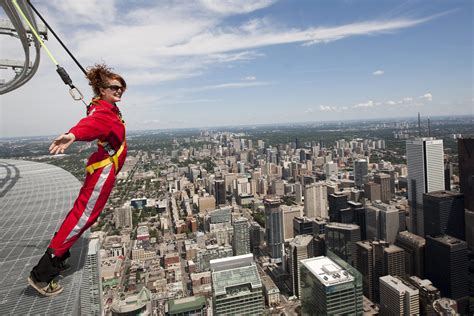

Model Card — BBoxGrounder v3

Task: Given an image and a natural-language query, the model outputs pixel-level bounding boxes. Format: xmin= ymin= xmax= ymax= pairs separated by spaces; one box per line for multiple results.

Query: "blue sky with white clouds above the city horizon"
xmin=0 ymin=0 xmax=474 ymax=136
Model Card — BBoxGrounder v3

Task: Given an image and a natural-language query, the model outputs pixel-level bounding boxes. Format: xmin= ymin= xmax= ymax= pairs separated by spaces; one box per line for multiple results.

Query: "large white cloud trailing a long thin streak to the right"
xmin=32 ymin=0 xmax=444 ymax=84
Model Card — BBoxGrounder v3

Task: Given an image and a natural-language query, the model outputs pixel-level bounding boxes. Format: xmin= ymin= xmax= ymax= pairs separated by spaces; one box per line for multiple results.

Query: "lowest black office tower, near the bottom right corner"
xmin=425 ymin=235 xmax=469 ymax=313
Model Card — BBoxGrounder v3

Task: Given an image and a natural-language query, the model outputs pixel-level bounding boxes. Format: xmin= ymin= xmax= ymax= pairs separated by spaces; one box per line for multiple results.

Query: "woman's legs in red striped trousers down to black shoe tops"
xmin=32 ymin=164 xmax=115 ymax=282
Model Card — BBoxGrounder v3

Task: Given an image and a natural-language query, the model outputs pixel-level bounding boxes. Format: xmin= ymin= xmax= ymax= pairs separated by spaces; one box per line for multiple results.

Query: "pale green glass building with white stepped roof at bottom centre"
xmin=210 ymin=254 xmax=264 ymax=315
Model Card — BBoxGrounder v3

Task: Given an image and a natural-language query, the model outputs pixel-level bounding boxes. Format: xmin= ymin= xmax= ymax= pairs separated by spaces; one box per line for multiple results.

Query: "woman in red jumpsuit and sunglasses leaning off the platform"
xmin=28 ymin=65 xmax=127 ymax=296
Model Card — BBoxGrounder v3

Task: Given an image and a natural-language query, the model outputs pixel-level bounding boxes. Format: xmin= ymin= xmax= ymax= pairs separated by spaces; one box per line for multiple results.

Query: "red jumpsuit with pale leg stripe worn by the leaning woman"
xmin=49 ymin=100 xmax=127 ymax=257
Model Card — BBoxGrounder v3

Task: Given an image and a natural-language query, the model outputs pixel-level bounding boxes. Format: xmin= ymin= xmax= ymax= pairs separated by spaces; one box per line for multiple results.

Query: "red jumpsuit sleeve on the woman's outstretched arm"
xmin=69 ymin=108 xmax=111 ymax=142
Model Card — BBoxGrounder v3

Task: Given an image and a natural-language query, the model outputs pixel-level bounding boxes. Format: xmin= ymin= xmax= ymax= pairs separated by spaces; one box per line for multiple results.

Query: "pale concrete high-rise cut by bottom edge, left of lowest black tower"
xmin=380 ymin=275 xmax=420 ymax=316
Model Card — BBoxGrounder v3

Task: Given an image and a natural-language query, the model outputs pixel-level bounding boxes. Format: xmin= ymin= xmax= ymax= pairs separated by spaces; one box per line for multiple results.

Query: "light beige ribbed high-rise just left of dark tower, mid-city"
xmin=304 ymin=182 xmax=328 ymax=218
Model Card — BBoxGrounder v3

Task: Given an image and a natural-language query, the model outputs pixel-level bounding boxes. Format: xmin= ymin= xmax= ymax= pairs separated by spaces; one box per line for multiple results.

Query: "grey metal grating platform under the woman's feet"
xmin=0 ymin=159 xmax=88 ymax=315
